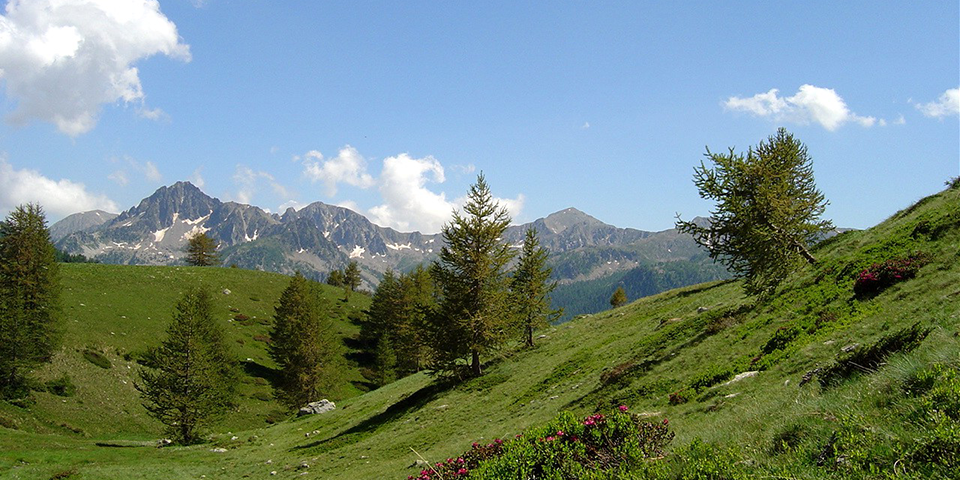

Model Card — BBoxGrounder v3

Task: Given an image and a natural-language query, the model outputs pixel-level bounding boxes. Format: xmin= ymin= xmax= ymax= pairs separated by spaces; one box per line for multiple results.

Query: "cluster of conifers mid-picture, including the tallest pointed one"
xmin=359 ymin=174 xmax=561 ymax=386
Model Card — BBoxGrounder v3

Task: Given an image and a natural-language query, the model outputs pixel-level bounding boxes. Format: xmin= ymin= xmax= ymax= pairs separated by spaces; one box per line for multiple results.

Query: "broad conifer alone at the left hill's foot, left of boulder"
xmin=135 ymin=288 xmax=238 ymax=444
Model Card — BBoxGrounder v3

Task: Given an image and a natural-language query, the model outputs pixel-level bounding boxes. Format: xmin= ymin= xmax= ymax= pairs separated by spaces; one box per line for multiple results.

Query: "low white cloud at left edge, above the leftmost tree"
xmin=0 ymin=158 xmax=120 ymax=220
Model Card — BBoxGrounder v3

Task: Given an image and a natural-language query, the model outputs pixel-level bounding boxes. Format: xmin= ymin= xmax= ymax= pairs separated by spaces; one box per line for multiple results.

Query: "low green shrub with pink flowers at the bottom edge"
xmin=408 ymin=405 xmax=674 ymax=480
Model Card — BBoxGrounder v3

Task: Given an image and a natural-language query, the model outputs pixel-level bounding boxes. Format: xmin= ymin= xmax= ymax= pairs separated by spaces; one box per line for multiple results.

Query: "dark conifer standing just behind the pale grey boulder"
xmin=269 ymin=272 xmax=342 ymax=408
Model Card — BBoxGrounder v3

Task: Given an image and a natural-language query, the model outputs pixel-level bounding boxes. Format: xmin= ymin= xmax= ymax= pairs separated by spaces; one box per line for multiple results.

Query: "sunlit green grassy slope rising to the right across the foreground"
xmin=0 ymin=183 xmax=960 ymax=479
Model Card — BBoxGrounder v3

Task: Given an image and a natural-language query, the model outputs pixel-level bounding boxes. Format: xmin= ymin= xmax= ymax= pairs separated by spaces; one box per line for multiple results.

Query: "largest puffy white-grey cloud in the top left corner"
xmin=0 ymin=0 xmax=190 ymax=136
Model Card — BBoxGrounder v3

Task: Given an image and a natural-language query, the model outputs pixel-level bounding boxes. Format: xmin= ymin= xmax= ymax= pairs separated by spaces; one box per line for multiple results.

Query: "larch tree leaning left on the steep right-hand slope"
xmin=677 ymin=128 xmax=833 ymax=295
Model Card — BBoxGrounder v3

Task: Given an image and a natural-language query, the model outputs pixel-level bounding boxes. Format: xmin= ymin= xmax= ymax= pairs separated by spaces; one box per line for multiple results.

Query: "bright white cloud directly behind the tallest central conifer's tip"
xmin=369 ymin=153 xmax=524 ymax=233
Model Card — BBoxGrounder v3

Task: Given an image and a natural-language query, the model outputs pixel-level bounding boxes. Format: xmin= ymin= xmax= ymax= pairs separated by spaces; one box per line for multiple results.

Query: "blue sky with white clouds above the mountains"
xmin=0 ymin=0 xmax=960 ymax=232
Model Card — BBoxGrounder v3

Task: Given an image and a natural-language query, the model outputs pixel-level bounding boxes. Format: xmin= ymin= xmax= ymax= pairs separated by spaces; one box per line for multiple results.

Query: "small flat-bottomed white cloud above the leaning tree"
xmin=723 ymin=85 xmax=885 ymax=131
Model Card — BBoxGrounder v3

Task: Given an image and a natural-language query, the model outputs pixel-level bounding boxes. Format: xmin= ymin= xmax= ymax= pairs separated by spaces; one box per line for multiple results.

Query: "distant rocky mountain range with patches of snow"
xmin=50 ymin=182 xmax=729 ymax=317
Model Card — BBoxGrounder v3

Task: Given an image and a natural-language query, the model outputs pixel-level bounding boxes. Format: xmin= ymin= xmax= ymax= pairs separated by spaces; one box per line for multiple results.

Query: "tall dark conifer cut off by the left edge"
xmin=0 ymin=204 xmax=60 ymax=397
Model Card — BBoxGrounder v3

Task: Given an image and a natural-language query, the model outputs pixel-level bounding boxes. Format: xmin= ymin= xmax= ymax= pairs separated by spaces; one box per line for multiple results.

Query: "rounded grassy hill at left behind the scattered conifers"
xmin=0 ymin=264 xmax=369 ymax=439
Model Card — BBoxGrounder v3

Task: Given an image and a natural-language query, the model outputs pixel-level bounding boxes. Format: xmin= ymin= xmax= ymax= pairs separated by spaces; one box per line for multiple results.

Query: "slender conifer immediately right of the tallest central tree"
xmin=510 ymin=228 xmax=563 ymax=347
